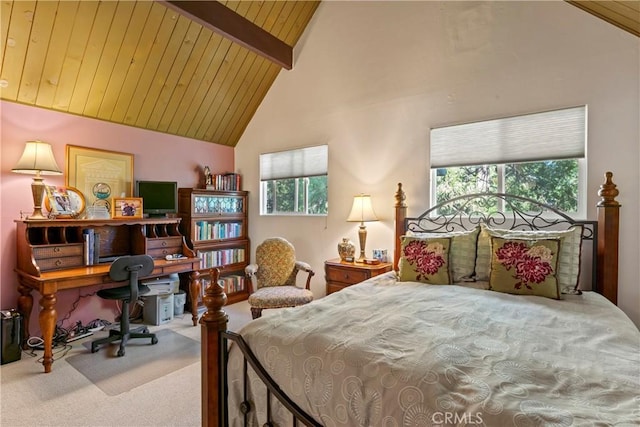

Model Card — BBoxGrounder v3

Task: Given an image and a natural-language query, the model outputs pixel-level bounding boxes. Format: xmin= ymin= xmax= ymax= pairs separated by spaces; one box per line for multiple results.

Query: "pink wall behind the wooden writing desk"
xmin=0 ymin=101 xmax=234 ymax=335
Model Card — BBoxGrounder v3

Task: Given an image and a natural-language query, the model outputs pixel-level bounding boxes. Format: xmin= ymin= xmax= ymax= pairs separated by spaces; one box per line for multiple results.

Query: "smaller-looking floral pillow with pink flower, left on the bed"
xmin=399 ymin=236 xmax=451 ymax=285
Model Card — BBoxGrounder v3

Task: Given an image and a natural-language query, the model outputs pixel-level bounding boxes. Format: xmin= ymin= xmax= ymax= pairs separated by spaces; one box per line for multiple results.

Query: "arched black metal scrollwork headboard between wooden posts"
xmin=404 ymin=193 xmax=599 ymax=291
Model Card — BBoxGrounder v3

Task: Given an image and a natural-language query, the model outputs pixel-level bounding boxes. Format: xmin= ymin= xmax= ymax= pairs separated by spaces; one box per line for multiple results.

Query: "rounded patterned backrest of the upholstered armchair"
xmin=256 ymin=237 xmax=296 ymax=288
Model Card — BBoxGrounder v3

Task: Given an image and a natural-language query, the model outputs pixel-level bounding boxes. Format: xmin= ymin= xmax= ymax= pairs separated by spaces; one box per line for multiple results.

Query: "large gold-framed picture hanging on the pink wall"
xmin=65 ymin=145 xmax=133 ymax=211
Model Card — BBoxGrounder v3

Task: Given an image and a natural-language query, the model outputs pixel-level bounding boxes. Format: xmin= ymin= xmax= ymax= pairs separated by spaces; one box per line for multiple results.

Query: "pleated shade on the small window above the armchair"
xmin=260 ymin=145 xmax=329 ymax=181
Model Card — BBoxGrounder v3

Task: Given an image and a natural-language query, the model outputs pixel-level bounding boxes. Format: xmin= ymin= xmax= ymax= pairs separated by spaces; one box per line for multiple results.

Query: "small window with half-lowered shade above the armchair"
xmin=260 ymin=145 xmax=329 ymax=215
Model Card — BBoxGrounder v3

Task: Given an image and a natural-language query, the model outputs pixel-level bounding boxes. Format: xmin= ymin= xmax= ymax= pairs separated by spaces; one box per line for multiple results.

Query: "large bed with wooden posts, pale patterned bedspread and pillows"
xmin=200 ymin=173 xmax=640 ymax=426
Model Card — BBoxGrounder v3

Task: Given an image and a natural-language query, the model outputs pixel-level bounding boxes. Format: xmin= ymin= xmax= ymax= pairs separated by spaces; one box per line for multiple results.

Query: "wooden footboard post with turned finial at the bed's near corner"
xmin=200 ymin=268 xmax=229 ymax=427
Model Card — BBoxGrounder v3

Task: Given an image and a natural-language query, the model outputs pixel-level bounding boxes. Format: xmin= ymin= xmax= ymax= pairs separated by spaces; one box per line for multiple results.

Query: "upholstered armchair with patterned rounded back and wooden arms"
xmin=245 ymin=237 xmax=315 ymax=319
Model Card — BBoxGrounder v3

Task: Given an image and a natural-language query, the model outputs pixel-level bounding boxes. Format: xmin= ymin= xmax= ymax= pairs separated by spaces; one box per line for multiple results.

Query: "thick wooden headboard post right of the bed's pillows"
xmin=597 ymin=172 xmax=620 ymax=305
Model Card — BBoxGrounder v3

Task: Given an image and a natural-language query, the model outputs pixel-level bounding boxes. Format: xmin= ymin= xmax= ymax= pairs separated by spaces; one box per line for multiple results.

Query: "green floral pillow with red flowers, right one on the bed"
xmin=489 ymin=237 xmax=560 ymax=299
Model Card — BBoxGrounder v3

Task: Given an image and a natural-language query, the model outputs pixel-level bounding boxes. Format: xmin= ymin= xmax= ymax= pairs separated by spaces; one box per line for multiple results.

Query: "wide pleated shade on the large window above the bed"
xmin=431 ymin=106 xmax=587 ymax=168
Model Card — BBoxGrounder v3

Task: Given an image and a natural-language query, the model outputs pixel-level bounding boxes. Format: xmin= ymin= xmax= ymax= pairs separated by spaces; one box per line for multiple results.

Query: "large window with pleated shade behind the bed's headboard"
xmin=431 ymin=106 xmax=586 ymax=215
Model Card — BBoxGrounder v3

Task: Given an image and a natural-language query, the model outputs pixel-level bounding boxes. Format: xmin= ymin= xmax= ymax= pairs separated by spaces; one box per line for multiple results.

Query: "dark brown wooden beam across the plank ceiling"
xmin=158 ymin=1 xmax=293 ymax=70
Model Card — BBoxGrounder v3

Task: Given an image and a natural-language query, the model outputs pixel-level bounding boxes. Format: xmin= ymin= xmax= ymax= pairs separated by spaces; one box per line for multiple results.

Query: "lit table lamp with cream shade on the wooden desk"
xmin=11 ymin=141 xmax=62 ymax=219
